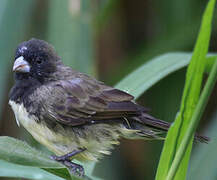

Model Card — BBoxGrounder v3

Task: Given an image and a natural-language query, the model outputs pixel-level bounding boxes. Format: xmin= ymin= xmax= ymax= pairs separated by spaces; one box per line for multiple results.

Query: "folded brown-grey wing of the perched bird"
xmin=39 ymin=76 xmax=141 ymax=126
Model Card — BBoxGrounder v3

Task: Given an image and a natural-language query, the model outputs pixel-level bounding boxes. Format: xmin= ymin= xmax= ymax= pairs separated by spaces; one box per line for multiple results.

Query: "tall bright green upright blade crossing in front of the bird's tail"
xmin=156 ymin=0 xmax=215 ymax=180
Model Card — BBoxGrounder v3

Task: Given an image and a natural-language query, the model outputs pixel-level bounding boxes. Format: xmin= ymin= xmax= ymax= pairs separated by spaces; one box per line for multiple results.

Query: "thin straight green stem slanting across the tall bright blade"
xmin=166 ymin=60 xmax=217 ymax=180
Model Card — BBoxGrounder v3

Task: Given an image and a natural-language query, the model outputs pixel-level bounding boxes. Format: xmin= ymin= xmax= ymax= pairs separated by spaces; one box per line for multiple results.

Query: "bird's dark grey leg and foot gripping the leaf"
xmin=51 ymin=148 xmax=86 ymax=176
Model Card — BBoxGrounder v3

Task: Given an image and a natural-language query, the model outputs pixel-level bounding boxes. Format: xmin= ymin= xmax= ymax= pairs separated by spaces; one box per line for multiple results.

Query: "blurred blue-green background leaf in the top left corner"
xmin=0 ymin=0 xmax=34 ymax=114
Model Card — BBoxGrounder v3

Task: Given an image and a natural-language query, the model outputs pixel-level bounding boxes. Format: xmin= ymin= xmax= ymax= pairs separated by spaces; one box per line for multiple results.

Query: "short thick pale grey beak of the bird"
xmin=13 ymin=56 xmax=30 ymax=73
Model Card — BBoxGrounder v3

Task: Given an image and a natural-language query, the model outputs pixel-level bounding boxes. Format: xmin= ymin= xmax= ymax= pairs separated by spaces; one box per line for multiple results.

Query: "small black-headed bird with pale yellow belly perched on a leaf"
xmin=9 ymin=38 xmax=208 ymax=176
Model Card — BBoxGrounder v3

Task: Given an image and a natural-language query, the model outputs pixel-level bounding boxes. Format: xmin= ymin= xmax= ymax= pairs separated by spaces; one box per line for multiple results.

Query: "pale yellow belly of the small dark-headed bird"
xmin=9 ymin=101 xmax=132 ymax=160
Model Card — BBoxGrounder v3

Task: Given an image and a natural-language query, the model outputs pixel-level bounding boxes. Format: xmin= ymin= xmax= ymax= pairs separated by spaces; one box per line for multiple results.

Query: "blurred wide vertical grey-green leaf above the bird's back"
xmin=48 ymin=0 xmax=95 ymax=75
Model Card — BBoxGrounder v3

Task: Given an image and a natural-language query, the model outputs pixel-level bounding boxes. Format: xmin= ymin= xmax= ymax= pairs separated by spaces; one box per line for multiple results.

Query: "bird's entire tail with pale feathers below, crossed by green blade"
xmin=121 ymin=113 xmax=209 ymax=143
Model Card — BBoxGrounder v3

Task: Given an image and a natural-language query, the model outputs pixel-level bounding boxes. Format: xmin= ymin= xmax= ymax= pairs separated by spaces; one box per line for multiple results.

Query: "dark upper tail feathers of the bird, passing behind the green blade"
xmin=131 ymin=113 xmax=210 ymax=143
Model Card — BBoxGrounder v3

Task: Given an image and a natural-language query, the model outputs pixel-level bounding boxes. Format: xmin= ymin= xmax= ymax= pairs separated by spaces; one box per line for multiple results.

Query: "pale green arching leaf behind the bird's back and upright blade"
xmin=115 ymin=52 xmax=216 ymax=98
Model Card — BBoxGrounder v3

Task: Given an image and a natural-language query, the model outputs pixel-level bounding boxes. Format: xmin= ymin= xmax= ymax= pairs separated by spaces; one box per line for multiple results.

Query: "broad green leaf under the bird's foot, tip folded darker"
xmin=0 ymin=136 xmax=97 ymax=179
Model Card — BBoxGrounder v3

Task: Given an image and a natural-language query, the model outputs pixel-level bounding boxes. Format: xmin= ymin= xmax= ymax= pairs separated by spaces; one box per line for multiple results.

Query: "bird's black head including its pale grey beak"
xmin=13 ymin=39 xmax=61 ymax=82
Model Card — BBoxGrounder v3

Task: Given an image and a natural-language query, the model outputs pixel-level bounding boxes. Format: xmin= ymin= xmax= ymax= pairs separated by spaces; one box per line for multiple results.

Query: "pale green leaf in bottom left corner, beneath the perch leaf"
xmin=0 ymin=160 xmax=64 ymax=180
